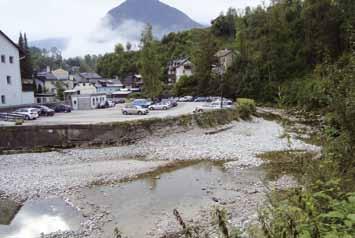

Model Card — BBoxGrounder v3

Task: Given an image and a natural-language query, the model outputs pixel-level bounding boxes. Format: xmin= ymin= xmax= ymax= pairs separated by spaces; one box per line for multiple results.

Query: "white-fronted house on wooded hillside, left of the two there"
xmin=168 ymin=58 xmax=193 ymax=84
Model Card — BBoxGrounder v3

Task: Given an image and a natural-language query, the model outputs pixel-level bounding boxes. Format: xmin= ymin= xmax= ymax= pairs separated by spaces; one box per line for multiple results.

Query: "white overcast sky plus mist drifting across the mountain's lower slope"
xmin=0 ymin=0 xmax=268 ymax=57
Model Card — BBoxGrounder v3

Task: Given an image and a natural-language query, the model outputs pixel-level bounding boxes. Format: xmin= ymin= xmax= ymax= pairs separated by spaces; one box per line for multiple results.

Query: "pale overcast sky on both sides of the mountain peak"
xmin=0 ymin=0 xmax=268 ymax=55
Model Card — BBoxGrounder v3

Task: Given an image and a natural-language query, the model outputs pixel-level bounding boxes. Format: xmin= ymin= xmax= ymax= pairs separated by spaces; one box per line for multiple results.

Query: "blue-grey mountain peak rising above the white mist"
xmin=107 ymin=0 xmax=202 ymax=35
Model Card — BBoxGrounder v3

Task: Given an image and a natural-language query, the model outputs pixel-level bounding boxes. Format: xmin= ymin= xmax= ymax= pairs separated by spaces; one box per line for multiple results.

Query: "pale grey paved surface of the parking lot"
xmin=24 ymin=102 xmax=203 ymax=125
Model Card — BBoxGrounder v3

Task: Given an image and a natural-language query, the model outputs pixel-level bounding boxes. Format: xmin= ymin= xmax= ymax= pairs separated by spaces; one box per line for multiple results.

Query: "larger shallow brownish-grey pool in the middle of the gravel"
xmin=84 ymin=162 xmax=239 ymax=238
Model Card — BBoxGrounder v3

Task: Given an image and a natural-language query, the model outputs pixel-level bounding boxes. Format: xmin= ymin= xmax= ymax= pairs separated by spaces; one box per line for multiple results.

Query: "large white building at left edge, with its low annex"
xmin=0 ymin=30 xmax=34 ymax=107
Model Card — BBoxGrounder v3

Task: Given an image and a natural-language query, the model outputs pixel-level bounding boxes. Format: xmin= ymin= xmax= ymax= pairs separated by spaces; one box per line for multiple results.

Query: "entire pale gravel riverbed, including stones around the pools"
xmin=0 ymin=118 xmax=319 ymax=237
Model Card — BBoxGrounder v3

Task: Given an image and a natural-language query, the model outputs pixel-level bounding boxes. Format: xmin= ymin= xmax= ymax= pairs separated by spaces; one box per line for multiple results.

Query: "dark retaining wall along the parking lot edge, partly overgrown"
xmin=0 ymin=110 xmax=239 ymax=153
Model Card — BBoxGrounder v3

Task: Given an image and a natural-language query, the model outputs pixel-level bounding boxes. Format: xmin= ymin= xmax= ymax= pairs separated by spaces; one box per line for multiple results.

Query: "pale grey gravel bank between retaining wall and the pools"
xmin=0 ymin=118 xmax=318 ymax=199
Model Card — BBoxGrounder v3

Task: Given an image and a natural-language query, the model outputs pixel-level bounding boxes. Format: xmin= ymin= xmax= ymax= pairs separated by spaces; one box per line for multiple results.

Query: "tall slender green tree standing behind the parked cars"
xmin=139 ymin=25 xmax=163 ymax=99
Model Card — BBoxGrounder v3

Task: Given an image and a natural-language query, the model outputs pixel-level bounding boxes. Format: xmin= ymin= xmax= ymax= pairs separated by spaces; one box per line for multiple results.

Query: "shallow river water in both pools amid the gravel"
xmin=0 ymin=162 xmax=268 ymax=238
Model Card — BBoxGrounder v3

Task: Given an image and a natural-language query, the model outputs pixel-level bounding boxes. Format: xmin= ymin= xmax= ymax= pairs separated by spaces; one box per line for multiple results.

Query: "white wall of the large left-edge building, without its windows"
xmin=0 ymin=35 xmax=25 ymax=107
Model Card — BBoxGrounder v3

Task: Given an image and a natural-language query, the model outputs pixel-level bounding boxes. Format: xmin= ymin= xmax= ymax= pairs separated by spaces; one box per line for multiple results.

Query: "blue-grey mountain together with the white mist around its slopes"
xmin=30 ymin=0 xmax=204 ymax=57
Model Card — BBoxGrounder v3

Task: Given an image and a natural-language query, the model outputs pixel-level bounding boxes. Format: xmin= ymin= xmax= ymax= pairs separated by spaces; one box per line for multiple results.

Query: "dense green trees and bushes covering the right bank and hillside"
xmin=165 ymin=0 xmax=355 ymax=238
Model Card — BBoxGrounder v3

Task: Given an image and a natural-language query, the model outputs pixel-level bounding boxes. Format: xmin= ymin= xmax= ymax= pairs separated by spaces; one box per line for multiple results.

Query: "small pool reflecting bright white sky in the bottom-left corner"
xmin=0 ymin=199 xmax=80 ymax=238
